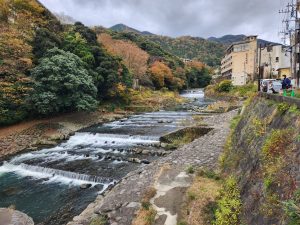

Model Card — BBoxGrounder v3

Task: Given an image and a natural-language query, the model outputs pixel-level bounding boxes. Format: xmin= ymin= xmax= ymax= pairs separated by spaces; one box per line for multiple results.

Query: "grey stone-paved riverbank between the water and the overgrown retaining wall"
xmin=68 ymin=110 xmax=237 ymax=225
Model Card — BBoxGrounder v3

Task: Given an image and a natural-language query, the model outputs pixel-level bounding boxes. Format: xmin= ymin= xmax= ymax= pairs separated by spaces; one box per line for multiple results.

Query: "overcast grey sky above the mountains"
xmin=40 ymin=0 xmax=289 ymax=42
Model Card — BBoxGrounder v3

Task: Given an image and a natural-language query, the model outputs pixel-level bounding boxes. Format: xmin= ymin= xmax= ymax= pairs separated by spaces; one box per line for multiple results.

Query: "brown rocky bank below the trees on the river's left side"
xmin=0 ymin=111 xmax=132 ymax=161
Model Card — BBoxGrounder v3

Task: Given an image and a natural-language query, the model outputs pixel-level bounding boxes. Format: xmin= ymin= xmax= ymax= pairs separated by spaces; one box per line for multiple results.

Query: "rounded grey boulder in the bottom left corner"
xmin=0 ymin=208 xmax=34 ymax=225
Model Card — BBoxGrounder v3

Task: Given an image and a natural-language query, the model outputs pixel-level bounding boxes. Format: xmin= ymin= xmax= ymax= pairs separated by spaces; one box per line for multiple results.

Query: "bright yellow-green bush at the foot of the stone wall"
xmin=215 ymin=176 xmax=242 ymax=225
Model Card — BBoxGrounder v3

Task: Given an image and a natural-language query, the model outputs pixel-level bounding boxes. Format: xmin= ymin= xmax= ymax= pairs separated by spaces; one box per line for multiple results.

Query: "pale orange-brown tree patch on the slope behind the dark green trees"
xmin=98 ymin=33 xmax=149 ymax=79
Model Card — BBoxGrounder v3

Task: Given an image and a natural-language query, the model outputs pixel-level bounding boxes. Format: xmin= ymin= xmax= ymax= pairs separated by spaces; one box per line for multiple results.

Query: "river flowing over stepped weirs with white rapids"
xmin=0 ymin=90 xmax=210 ymax=225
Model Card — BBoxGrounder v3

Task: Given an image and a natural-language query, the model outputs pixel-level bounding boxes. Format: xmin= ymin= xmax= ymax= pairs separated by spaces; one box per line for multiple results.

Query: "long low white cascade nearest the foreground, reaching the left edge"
xmin=0 ymin=162 xmax=114 ymax=185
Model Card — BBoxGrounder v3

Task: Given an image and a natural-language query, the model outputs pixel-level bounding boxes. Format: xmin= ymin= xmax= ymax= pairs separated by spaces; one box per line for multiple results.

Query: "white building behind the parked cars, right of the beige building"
xmin=261 ymin=44 xmax=292 ymax=79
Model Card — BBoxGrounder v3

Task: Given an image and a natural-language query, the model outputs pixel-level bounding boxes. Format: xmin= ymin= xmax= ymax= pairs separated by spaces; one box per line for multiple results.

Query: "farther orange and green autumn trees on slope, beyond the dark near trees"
xmin=97 ymin=28 xmax=211 ymax=90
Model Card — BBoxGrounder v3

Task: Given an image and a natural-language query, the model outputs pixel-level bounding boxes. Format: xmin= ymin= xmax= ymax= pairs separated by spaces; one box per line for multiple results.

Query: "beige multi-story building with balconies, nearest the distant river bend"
xmin=221 ymin=36 xmax=257 ymax=86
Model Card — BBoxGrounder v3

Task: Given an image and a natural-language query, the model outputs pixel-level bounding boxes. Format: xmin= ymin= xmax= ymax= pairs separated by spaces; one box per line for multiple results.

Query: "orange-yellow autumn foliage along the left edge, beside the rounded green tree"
xmin=0 ymin=0 xmax=61 ymax=125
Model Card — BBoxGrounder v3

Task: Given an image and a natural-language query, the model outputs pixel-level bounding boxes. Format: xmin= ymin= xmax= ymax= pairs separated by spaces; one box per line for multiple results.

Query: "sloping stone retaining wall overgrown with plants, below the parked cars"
xmin=221 ymin=96 xmax=300 ymax=225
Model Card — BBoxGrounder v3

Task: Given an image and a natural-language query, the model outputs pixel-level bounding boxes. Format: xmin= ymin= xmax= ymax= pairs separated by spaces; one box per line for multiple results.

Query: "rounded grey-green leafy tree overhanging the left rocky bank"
xmin=30 ymin=48 xmax=97 ymax=115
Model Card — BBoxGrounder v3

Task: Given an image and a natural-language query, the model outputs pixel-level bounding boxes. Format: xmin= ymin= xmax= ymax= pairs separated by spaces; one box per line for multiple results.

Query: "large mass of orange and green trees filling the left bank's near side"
xmin=0 ymin=0 xmax=132 ymax=125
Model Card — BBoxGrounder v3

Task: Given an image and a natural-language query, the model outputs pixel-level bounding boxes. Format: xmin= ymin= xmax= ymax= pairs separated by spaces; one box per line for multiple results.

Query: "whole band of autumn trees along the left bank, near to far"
xmin=0 ymin=0 xmax=211 ymax=125
